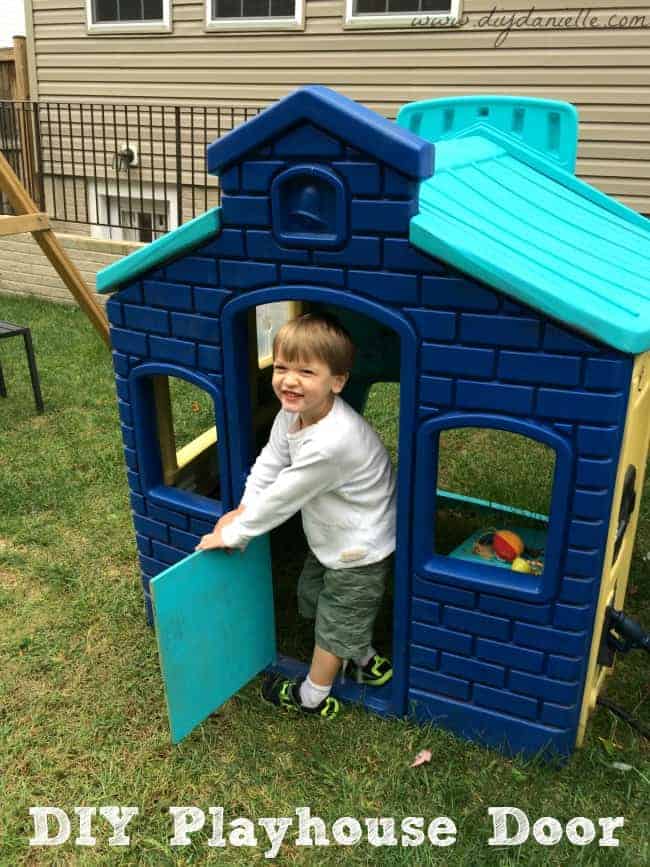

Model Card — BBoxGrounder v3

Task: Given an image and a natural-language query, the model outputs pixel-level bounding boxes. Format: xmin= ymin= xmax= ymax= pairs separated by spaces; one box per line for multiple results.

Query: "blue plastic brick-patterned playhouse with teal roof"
xmin=98 ymin=87 xmax=650 ymax=755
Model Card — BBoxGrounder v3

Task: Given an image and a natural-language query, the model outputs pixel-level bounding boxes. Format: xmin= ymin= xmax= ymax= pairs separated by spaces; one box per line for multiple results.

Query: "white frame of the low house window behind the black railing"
xmin=87 ymin=178 xmax=178 ymax=243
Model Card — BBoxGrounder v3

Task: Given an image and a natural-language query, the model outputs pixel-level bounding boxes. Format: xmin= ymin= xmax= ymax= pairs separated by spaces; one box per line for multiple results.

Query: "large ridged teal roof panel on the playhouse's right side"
xmin=410 ymin=130 xmax=650 ymax=353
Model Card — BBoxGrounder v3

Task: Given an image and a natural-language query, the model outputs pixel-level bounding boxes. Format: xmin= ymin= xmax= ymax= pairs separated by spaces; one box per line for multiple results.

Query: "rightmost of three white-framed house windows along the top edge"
xmin=344 ymin=0 xmax=460 ymax=29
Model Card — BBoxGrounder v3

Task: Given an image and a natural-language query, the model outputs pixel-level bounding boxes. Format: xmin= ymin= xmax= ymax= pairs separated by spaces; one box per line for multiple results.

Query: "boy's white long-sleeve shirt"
xmin=221 ymin=396 xmax=395 ymax=569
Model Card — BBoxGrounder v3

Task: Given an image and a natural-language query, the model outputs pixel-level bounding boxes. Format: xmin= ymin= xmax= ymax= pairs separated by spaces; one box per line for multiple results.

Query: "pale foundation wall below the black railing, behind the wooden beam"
xmin=0 ymin=232 xmax=142 ymax=306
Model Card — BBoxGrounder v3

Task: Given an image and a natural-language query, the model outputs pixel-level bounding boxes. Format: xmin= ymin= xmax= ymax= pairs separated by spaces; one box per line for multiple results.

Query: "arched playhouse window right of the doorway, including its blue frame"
xmin=414 ymin=415 xmax=570 ymax=601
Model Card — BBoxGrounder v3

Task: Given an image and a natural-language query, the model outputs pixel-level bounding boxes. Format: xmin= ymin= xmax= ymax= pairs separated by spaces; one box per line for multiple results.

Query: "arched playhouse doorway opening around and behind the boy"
xmin=224 ymin=287 xmax=414 ymax=713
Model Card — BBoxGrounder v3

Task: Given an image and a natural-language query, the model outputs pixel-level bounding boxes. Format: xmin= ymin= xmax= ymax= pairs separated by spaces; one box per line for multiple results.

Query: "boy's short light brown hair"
xmin=273 ymin=313 xmax=355 ymax=376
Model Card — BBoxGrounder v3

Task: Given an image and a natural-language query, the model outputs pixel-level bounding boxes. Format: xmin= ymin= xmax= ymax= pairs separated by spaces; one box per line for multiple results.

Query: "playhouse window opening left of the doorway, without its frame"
xmin=154 ymin=376 xmax=220 ymax=499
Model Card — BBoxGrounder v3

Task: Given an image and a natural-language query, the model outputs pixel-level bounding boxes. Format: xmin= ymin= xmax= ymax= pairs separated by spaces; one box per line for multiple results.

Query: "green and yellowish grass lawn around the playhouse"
xmin=0 ymin=296 xmax=650 ymax=867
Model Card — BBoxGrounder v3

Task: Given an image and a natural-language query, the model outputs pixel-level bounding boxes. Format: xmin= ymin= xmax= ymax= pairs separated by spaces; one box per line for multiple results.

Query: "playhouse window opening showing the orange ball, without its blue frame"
xmin=434 ymin=427 xmax=556 ymax=575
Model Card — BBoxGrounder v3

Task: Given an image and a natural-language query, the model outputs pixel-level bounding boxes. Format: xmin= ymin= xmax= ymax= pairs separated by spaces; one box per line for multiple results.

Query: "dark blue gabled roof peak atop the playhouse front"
xmin=207 ymin=85 xmax=433 ymax=179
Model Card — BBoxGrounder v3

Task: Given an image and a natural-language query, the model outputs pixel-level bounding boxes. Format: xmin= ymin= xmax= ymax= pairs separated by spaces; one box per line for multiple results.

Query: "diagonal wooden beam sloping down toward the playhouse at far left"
xmin=0 ymin=153 xmax=111 ymax=348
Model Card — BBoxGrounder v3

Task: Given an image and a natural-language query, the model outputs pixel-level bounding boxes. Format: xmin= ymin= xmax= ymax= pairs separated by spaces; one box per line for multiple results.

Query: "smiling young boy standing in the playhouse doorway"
xmin=197 ymin=314 xmax=395 ymax=719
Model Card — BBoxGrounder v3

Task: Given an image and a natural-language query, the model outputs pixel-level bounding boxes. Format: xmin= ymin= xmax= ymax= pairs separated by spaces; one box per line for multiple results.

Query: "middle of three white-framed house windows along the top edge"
xmin=206 ymin=0 xmax=305 ymax=30
